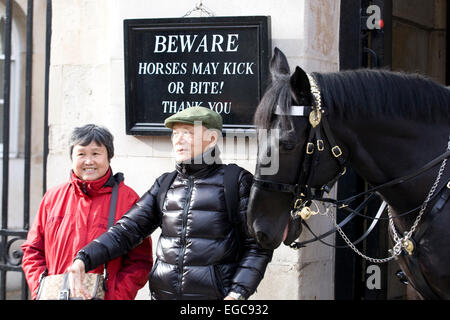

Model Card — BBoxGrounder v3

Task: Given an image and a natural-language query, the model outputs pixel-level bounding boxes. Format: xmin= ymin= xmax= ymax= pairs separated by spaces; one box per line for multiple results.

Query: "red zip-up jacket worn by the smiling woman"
xmin=22 ymin=169 xmax=153 ymax=300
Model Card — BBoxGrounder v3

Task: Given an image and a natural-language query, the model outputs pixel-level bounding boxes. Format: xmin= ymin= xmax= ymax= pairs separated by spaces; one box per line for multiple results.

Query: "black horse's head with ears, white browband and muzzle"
xmin=247 ymin=48 xmax=346 ymax=249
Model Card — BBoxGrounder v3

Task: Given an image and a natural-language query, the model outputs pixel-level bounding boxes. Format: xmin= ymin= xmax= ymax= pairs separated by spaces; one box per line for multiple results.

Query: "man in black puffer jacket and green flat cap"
xmin=69 ymin=107 xmax=273 ymax=299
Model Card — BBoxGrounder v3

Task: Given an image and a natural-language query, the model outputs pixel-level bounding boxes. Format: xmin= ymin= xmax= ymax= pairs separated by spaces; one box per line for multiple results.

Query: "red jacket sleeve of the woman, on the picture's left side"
xmin=21 ymin=196 xmax=47 ymax=299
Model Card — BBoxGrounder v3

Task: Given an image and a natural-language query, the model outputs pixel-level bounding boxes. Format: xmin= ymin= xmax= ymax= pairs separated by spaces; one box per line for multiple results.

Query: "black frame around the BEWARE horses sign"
xmin=123 ymin=16 xmax=271 ymax=136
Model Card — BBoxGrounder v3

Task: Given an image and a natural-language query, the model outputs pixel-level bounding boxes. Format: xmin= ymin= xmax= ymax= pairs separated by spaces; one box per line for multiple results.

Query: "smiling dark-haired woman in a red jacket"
xmin=22 ymin=124 xmax=153 ymax=300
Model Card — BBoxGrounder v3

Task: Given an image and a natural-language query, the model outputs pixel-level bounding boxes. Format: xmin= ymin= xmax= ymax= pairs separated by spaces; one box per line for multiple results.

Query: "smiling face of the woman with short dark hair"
xmin=72 ymin=141 xmax=109 ymax=181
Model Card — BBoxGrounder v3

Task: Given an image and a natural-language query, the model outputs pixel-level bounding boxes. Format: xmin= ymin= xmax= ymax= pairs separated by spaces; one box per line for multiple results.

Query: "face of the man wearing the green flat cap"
xmin=172 ymin=123 xmax=217 ymax=163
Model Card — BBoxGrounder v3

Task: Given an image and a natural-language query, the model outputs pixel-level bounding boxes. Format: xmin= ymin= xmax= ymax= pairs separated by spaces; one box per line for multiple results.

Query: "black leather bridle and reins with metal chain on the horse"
xmin=254 ymin=74 xmax=450 ymax=255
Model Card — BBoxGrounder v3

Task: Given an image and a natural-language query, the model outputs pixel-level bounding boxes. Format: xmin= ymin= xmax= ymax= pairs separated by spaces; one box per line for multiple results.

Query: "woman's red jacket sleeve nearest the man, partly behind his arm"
xmin=108 ymin=189 xmax=153 ymax=300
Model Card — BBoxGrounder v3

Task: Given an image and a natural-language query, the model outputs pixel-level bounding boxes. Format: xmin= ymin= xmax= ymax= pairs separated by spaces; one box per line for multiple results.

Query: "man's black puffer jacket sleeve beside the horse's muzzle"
xmin=231 ymin=171 xmax=273 ymax=299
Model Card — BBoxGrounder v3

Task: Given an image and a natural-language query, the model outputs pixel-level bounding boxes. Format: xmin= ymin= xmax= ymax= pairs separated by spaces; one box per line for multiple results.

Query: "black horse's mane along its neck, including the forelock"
xmin=255 ymin=69 xmax=450 ymax=127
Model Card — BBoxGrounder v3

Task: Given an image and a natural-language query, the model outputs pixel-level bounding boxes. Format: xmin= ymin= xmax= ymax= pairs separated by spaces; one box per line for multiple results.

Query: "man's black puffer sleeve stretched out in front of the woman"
xmin=75 ymin=176 xmax=163 ymax=272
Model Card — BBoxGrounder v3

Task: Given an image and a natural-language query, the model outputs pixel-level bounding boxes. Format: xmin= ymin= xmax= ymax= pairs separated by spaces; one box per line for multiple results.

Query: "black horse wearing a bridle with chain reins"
xmin=248 ymin=49 xmax=450 ymax=299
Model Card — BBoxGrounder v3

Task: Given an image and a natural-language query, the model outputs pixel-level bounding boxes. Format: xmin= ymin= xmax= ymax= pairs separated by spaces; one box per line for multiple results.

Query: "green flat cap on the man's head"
xmin=164 ymin=107 xmax=222 ymax=131
